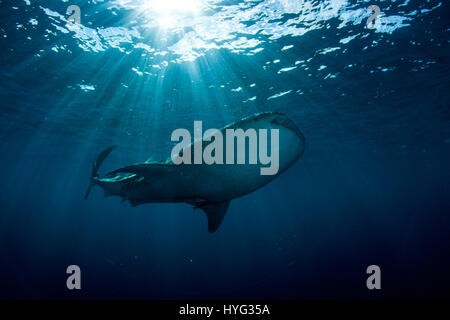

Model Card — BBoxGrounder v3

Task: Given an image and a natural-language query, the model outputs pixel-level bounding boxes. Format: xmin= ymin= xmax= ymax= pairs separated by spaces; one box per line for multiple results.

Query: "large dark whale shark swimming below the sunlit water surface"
xmin=85 ymin=112 xmax=305 ymax=233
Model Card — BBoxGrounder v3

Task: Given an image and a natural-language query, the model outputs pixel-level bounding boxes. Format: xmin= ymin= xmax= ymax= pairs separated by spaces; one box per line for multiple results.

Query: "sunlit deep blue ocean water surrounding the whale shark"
xmin=0 ymin=0 xmax=450 ymax=299
